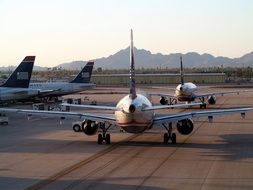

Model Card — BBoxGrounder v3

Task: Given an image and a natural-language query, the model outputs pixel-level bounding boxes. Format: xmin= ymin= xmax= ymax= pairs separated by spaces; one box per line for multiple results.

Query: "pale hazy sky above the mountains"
xmin=0 ymin=0 xmax=253 ymax=67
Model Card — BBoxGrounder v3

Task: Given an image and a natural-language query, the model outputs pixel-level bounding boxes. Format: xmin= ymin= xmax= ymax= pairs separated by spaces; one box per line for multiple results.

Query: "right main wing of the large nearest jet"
xmin=154 ymin=108 xmax=253 ymax=124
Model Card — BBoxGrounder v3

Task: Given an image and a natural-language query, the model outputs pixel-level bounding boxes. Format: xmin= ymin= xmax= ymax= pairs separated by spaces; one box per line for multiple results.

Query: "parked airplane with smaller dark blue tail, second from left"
xmin=29 ymin=61 xmax=95 ymax=98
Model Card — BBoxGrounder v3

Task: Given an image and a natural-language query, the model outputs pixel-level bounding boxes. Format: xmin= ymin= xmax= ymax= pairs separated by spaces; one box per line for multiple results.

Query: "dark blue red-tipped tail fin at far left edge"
xmin=1 ymin=56 xmax=35 ymax=88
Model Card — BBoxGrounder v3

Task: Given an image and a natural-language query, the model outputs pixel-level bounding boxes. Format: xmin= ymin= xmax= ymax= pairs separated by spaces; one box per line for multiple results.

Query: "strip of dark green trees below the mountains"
xmin=0 ymin=67 xmax=253 ymax=82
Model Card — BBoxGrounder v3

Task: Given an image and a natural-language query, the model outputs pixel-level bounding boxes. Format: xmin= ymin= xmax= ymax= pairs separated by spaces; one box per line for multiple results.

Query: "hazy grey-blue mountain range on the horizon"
xmin=58 ymin=47 xmax=253 ymax=70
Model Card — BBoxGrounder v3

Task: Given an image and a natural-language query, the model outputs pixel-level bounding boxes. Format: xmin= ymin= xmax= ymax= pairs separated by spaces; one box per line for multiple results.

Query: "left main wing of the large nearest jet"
xmin=0 ymin=108 xmax=116 ymax=124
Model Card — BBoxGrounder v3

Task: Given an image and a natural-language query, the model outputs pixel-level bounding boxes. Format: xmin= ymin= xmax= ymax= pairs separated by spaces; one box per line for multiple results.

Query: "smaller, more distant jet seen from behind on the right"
xmin=154 ymin=57 xmax=253 ymax=108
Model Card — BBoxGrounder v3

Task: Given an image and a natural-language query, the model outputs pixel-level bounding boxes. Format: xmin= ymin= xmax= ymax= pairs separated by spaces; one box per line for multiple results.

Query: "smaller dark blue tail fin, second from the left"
xmin=70 ymin=61 xmax=94 ymax=83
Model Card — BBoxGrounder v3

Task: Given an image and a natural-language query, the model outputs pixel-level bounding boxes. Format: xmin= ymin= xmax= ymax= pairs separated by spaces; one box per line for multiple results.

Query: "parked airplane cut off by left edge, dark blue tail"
xmin=0 ymin=56 xmax=38 ymax=102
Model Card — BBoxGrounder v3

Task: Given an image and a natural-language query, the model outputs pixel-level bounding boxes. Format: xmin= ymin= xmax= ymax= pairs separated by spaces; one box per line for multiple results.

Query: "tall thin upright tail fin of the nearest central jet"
xmin=129 ymin=29 xmax=137 ymax=99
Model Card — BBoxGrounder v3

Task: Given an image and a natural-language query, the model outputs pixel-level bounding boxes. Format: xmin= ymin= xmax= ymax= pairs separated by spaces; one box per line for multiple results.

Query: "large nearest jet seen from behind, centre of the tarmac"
xmin=0 ymin=30 xmax=253 ymax=144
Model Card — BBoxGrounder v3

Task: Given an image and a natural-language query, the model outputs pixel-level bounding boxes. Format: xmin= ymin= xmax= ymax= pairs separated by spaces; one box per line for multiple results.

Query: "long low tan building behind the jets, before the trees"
xmin=91 ymin=73 xmax=226 ymax=85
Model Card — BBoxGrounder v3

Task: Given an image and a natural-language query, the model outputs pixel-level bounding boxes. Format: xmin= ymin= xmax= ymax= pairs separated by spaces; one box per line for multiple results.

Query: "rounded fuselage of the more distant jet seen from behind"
xmin=175 ymin=82 xmax=197 ymax=102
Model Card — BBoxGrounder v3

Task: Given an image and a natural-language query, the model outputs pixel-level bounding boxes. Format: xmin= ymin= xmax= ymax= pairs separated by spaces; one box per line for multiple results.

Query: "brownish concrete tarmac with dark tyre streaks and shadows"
xmin=0 ymin=89 xmax=253 ymax=190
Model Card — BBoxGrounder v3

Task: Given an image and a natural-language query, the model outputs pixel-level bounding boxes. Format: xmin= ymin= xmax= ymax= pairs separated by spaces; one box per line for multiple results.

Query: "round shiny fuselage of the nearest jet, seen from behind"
xmin=115 ymin=94 xmax=154 ymax=133
